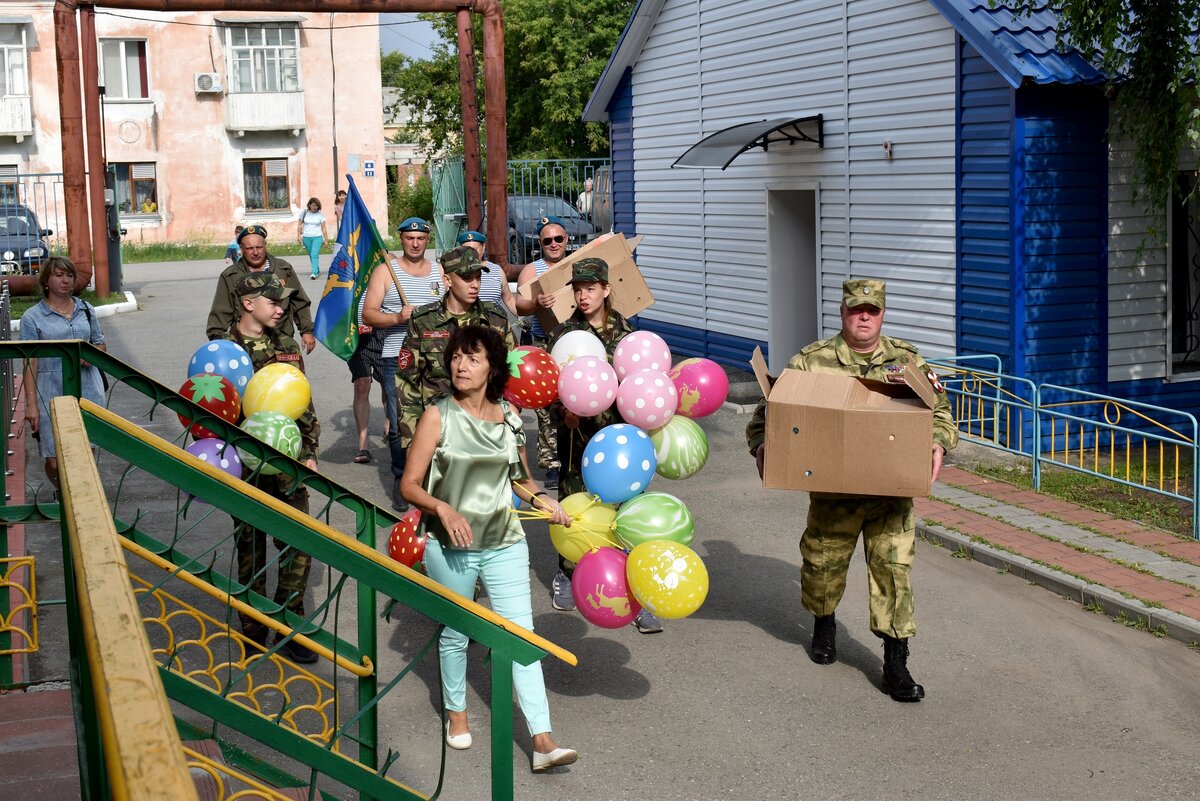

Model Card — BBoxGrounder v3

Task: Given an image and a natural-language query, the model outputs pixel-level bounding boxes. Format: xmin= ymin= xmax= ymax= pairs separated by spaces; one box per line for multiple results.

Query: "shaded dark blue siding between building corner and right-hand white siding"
xmin=1010 ymin=86 xmax=1108 ymax=392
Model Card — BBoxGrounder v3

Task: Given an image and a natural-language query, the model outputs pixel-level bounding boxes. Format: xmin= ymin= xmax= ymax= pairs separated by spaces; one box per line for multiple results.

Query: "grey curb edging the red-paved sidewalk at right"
xmin=917 ymin=522 xmax=1200 ymax=645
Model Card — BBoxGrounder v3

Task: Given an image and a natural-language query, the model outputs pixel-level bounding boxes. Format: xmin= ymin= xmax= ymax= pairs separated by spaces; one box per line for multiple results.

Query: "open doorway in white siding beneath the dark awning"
xmin=767 ymin=189 xmax=821 ymax=375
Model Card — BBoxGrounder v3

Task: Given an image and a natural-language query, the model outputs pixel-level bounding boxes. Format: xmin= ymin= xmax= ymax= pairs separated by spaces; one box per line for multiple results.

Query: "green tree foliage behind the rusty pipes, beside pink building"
xmin=383 ymin=0 xmax=635 ymax=158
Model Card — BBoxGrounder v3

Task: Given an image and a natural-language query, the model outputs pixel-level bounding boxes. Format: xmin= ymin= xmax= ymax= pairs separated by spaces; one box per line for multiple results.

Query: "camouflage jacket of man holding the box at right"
xmin=746 ymin=333 xmax=959 ymax=453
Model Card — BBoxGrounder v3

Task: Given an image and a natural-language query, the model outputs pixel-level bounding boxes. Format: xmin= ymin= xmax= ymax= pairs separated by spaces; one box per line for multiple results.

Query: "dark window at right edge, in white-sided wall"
xmin=1168 ymin=173 xmax=1200 ymax=374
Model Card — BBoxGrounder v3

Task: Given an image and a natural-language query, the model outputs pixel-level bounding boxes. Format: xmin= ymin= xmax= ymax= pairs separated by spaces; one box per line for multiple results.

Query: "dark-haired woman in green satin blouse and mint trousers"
xmin=400 ymin=325 xmax=578 ymax=772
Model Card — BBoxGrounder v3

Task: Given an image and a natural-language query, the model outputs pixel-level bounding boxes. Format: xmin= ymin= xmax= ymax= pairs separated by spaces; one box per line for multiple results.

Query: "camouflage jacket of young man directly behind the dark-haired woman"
xmin=396 ymin=295 xmax=516 ymax=447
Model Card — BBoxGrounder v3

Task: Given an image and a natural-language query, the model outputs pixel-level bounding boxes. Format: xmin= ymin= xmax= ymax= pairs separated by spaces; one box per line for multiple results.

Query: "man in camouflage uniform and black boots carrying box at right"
xmin=746 ymin=278 xmax=959 ymax=701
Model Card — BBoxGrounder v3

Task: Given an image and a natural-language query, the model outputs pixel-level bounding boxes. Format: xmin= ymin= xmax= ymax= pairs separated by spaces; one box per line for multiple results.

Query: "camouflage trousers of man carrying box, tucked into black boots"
xmin=800 ymin=494 xmax=917 ymax=639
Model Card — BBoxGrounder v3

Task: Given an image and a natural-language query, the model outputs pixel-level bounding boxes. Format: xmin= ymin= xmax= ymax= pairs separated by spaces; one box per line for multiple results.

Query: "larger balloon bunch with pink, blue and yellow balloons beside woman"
xmin=550 ymin=331 xmax=730 ymax=628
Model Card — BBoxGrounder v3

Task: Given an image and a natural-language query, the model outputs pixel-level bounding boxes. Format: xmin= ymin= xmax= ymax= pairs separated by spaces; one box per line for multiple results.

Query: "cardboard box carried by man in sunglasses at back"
xmin=517 ymin=234 xmax=654 ymax=332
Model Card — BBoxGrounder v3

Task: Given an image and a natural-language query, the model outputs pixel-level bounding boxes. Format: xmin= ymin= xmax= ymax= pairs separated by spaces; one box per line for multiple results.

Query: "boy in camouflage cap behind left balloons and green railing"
xmin=224 ymin=272 xmax=320 ymax=663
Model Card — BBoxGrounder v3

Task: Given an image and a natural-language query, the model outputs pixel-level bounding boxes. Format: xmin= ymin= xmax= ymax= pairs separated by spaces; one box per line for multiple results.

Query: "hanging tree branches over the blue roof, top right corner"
xmin=1036 ymin=0 xmax=1200 ymax=219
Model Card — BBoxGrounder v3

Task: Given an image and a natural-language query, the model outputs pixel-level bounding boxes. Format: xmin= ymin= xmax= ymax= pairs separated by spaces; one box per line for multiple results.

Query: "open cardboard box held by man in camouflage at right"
xmin=750 ymin=348 xmax=937 ymax=498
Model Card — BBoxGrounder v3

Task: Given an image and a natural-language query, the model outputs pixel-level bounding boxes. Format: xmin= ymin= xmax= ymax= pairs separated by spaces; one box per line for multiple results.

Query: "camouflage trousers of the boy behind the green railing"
xmin=234 ymin=476 xmax=312 ymax=642
